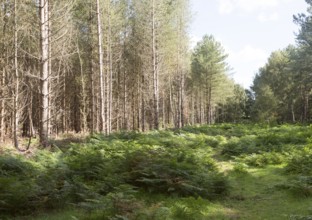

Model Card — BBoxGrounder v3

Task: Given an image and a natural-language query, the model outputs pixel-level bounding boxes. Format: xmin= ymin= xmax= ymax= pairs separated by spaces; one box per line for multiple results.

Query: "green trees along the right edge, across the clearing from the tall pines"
xmin=250 ymin=0 xmax=312 ymax=123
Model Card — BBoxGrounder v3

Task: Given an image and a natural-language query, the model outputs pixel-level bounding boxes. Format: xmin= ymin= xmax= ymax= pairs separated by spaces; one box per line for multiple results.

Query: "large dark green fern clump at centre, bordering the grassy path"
xmin=123 ymin=150 xmax=228 ymax=198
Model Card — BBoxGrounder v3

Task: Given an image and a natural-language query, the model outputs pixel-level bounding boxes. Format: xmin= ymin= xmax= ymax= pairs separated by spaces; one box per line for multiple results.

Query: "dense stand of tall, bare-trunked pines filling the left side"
xmin=0 ymin=0 xmax=241 ymax=148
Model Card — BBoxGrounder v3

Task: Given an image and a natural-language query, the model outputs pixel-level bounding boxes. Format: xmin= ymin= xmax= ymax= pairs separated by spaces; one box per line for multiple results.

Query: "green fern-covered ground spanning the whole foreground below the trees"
xmin=0 ymin=124 xmax=312 ymax=220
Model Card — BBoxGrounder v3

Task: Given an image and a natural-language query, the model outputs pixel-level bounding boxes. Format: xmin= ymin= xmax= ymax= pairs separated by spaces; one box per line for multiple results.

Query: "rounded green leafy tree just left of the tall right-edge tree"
xmin=252 ymin=46 xmax=306 ymax=123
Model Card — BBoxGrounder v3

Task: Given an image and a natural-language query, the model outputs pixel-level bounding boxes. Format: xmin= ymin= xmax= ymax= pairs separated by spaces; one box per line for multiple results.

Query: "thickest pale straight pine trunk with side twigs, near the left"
xmin=40 ymin=0 xmax=49 ymax=147
